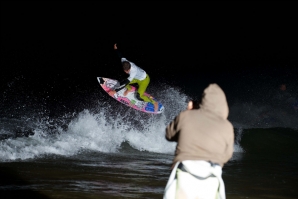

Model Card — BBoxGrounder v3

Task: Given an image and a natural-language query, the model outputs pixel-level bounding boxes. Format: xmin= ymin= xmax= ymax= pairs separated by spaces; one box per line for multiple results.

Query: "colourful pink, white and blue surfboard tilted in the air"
xmin=97 ymin=77 xmax=164 ymax=114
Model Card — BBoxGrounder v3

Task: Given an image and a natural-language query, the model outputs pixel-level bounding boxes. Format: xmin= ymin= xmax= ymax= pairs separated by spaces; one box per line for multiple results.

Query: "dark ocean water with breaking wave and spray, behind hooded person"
xmin=0 ymin=75 xmax=298 ymax=199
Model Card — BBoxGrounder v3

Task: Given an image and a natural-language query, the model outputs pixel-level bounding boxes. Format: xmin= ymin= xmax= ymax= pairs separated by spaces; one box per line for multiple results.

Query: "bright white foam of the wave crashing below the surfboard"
xmin=0 ymin=85 xmax=251 ymax=161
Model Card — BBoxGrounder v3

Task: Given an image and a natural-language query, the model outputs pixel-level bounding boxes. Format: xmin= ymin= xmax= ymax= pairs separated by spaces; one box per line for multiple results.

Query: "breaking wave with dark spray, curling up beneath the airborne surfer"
xmin=0 ymin=79 xmax=188 ymax=161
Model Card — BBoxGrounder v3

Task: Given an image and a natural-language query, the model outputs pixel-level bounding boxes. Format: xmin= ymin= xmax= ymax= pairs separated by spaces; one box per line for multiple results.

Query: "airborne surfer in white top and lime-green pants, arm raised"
xmin=109 ymin=44 xmax=158 ymax=111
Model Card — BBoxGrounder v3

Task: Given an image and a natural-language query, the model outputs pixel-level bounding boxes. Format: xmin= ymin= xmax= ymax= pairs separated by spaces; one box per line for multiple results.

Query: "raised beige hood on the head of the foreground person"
xmin=200 ymin=84 xmax=229 ymax=119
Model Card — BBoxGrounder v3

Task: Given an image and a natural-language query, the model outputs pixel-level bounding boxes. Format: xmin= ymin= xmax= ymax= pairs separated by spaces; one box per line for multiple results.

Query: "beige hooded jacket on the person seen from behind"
xmin=166 ymin=84 xmax=234 ymax=167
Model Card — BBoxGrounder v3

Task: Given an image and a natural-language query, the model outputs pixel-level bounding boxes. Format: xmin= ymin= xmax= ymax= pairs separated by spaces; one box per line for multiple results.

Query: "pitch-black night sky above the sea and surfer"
xmin=1 ymin=1 xmax=298 ymax=101
